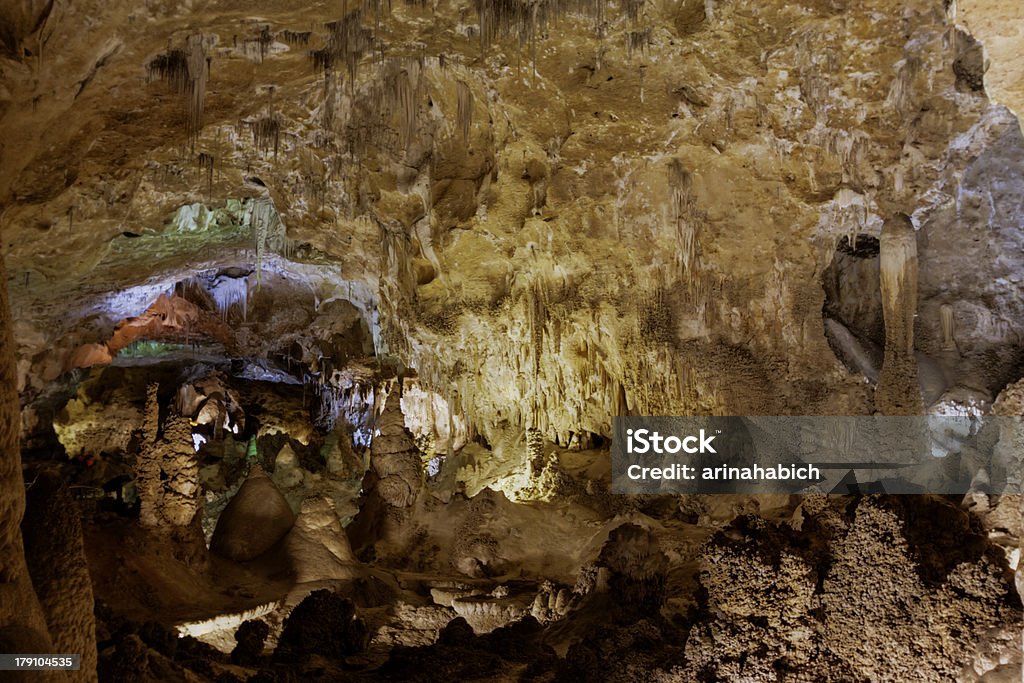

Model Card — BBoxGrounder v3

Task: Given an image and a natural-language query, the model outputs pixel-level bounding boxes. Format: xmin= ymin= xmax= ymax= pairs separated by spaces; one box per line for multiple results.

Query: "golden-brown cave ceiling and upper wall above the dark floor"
xmin=0 ymin=0 xmax=1024 ymax=432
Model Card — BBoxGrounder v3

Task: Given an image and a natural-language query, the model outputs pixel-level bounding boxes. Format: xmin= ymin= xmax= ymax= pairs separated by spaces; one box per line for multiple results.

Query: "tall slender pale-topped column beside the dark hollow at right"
xmin=874 ymin=213 xmax=924 ymax=415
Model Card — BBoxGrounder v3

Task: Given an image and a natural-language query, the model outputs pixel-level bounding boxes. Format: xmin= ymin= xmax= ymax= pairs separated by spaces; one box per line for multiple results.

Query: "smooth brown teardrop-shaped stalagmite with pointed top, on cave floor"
xmin=210 ymin=465 xmax=295 ymax=562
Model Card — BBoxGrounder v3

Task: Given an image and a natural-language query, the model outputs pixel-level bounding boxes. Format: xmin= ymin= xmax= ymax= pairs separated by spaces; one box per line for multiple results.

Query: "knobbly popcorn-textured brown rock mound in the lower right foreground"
xmin=686 ymin=499 xmax=1020 ymax=681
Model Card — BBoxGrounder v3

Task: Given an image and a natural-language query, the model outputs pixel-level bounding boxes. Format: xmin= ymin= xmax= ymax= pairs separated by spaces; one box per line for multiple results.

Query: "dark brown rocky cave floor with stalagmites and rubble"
xmin=12 ymin=366 xmax=1022 ymax=681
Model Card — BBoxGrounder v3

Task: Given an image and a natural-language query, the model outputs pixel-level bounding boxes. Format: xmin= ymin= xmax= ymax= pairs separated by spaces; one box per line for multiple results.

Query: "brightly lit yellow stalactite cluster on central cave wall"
xmin=403 ymin=273 xmax=715 ymax=445
